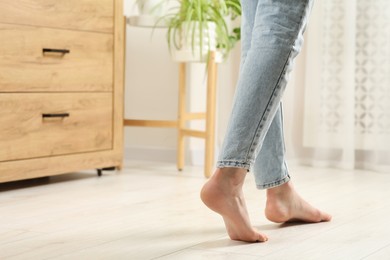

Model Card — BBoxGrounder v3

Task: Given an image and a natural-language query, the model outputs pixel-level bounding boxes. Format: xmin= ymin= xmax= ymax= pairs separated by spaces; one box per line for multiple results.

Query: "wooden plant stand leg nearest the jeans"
xmin=204 ymin=52 xmax=217 ymax=178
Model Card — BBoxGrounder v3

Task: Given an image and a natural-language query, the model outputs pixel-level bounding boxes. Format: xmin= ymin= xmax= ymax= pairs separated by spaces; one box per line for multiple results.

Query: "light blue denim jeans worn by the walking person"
xmin=217 ymin=0 xmax=313 ymax=189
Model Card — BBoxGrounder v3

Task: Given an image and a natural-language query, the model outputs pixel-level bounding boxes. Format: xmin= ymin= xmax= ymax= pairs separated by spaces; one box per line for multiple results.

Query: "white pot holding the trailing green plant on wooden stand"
xmin=172 ymin=21 xmax=217 ymax=62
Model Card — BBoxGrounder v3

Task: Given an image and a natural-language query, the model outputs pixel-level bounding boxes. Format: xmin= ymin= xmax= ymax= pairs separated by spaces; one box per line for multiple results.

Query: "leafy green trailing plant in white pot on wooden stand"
xmin=162 ymin=0 xmax=241 ymax=62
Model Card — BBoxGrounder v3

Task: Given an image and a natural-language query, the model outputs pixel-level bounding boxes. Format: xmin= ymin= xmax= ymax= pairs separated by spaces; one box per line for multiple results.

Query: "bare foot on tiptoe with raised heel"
xmin=201 ymin=168 xmax=268 ymax=242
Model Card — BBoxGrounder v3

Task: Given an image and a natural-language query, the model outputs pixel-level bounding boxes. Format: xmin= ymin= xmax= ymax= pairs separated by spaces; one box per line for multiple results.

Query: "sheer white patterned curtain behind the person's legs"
xmin=284 ymin=0 xmax=390 ymax=173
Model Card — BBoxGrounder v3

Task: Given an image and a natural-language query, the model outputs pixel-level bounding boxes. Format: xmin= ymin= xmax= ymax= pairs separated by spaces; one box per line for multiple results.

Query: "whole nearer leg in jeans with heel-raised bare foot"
xmin=201 ymin=0 xmax=330 ymax=242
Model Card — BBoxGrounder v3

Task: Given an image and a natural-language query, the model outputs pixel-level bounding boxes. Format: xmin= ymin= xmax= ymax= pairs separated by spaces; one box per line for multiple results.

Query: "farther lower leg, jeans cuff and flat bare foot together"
xmin=253 ymin=105 xmax=331 ymax=223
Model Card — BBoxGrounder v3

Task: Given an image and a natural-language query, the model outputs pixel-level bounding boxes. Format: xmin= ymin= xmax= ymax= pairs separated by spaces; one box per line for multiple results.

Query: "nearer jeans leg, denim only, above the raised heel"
xmin=218 ymin=0 xmax=312 ymax=170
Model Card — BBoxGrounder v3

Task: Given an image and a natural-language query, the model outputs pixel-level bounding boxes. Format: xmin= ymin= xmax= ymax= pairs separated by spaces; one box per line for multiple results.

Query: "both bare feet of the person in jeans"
xmin=201 ymin=168 xmax=332 ymax=242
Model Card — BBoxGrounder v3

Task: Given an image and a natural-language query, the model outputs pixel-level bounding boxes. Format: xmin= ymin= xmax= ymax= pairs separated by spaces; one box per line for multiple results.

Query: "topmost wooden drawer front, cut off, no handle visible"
xmin=0 ymin=0 xmax=114 ymax=33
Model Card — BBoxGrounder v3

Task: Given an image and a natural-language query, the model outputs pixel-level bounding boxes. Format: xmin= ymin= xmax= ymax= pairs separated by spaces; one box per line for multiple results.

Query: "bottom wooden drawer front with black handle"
xmin=0 ymin=93 xmax=112 ymax=161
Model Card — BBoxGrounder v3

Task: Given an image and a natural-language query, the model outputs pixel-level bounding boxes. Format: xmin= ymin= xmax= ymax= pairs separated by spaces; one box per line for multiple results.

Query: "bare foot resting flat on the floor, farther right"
xmin=265 ymin=181 xmax=332 ymax=223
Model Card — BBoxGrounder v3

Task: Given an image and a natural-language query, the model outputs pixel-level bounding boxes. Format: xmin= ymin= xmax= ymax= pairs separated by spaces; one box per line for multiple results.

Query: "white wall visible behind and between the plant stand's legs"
xmin=125 ymin=1 xmax=240 ymax=164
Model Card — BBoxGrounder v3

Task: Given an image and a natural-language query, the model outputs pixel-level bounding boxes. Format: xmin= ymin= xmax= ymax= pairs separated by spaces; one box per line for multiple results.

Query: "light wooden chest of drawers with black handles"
xmin=0 ymin=0 xmax=125 ymax=182
